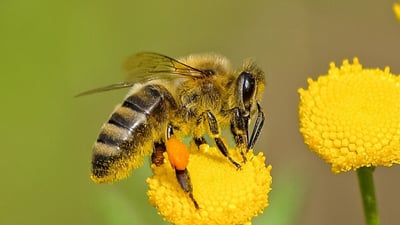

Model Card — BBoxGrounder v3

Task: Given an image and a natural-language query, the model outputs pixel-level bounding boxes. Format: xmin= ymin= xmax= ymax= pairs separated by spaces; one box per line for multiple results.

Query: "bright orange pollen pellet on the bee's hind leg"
xmin=165 ymin=137 xmax=189 ymax=170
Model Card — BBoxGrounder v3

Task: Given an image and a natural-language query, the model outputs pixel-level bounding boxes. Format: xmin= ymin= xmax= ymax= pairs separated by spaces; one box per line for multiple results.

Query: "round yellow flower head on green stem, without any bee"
xmin=299 ymin=58 xmax=400 ymax=173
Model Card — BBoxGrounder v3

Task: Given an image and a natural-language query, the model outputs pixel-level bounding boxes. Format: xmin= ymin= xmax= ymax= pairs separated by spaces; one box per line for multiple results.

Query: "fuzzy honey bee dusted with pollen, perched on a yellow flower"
xmin=80 ymin=52 xmax=265 ymax=208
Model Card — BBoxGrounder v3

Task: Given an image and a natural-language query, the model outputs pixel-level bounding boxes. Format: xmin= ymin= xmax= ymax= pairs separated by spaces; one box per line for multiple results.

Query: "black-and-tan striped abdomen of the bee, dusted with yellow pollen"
xmin=92 ymin=85 xmax=176 ymax=182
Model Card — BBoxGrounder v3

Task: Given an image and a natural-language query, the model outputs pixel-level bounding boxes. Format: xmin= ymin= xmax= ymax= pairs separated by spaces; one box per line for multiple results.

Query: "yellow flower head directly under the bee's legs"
xmin=147 ymin=144 xmax=272 ymax=225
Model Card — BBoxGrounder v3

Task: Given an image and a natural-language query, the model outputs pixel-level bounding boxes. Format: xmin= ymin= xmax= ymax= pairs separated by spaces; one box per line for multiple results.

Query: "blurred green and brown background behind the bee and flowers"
xmin=0 ymin=0 xmax=400 ymax=225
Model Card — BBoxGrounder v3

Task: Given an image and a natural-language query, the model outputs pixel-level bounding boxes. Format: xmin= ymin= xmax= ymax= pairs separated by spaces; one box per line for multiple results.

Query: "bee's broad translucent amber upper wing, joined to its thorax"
xmin=123 ymin=52 xmax=206 ymax=83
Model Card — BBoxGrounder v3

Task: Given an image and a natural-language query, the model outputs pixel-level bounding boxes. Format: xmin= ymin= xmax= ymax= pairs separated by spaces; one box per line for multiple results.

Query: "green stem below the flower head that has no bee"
xmin=357 ymin=167 xmax=380 ymax=225
